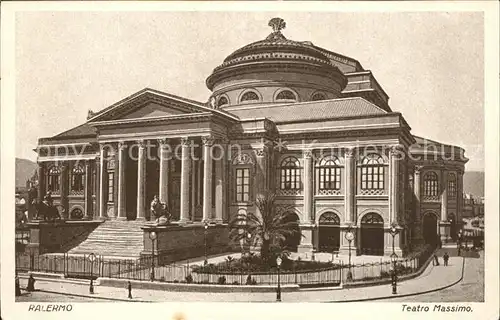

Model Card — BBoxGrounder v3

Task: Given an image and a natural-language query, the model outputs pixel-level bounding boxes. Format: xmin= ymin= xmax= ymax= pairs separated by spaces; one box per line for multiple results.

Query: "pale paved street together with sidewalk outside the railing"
xmin=16 ymin=249 xmax=484 ymax=302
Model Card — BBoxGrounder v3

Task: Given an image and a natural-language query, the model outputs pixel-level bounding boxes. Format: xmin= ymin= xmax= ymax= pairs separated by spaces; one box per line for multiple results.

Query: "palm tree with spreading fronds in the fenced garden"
xmin=230 ymin=193 xmax=300 ymax=261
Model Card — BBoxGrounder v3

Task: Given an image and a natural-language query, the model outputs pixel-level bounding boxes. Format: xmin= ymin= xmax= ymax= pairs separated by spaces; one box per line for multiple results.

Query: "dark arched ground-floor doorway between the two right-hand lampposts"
xmin=360 ymin=212 xmax=384 ymax=256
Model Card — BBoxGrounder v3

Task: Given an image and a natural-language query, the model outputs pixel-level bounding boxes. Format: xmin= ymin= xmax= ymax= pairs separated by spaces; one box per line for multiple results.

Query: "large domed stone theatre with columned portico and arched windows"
xmin=32 ymin=19 xmax=467 ymax=255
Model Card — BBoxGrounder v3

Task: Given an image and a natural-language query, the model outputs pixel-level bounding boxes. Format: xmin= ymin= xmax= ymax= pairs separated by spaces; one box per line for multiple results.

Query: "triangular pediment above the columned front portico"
xmin=88 ymin=89 xmax=211 ymax=122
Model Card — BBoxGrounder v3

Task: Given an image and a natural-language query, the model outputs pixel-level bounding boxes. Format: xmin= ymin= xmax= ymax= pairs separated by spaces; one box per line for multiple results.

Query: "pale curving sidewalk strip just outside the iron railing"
xmin=16 ymin=248 xmax=463 ymax=302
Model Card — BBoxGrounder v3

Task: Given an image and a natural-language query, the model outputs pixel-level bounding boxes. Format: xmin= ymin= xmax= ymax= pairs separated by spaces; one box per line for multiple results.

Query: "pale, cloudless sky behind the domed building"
xmin=15 ymin=11 xmax=484 ymax=171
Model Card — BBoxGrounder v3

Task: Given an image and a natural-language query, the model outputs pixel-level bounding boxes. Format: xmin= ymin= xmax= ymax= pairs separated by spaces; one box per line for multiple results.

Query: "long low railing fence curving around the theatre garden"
xmin=16 ymin=247 xmax=434 ymax=286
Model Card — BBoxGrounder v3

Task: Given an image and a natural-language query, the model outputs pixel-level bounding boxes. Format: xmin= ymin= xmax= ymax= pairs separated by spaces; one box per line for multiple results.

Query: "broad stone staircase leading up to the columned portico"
xmin=68 ymin=220 xmax=144 ymax=258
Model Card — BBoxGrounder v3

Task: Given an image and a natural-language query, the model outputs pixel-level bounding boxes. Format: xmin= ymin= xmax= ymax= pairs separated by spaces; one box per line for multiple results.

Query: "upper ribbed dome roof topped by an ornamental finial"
xmin=207 ymin=18 xmax=341 ymax=89
